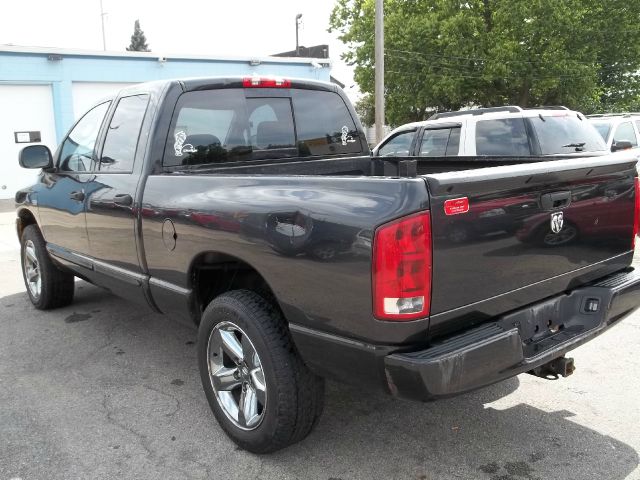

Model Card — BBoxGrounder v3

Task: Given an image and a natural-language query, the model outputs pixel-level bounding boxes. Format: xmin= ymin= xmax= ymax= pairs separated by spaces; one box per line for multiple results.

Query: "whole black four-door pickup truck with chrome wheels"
xmin=16 ymin=77 xmax=640 ymax=452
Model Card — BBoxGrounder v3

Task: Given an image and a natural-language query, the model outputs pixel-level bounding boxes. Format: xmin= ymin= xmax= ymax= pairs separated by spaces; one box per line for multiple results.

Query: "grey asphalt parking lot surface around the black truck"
xmin=0 ymin=210 xmax=640 ymax=480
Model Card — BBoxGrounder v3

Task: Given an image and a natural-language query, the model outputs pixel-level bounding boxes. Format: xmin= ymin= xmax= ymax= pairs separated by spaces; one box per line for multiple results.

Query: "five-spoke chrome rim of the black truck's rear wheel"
xmin=207 ymin=322 xmax=267 ymax=430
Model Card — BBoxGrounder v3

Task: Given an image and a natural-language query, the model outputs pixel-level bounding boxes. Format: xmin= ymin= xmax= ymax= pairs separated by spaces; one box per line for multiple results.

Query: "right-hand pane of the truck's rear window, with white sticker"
xmin=292 ymin=90 xmax=363 ymax=156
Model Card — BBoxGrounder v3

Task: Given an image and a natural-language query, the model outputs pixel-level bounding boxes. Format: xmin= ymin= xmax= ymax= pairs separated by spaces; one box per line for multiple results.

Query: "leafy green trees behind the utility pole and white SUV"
xmin=330 ymin=0 xmax=640 ymax=125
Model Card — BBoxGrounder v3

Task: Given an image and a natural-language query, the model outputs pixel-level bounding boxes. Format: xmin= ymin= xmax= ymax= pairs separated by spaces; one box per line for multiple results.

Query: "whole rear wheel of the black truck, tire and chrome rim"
xmin=198 ymin=290 xmax=324 ymax=453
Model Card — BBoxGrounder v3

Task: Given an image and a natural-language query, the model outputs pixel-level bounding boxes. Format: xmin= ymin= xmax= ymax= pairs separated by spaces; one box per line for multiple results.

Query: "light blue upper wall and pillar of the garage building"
xmin=0 ymin=47 xmax=330 ymax=141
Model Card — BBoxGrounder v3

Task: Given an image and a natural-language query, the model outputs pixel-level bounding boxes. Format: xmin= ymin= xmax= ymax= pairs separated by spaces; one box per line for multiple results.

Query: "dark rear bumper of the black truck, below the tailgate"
xmin=384 ymin=269 xmax=640 ymax=401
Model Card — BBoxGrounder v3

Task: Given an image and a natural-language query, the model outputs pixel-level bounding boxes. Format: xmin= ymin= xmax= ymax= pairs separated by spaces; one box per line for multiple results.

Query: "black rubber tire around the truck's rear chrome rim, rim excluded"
xmin=198 ymin=290 xmax=324 ymax=453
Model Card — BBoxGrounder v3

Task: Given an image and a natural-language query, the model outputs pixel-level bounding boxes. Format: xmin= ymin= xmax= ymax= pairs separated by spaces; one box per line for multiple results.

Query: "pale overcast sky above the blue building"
xmin=0 ymin=0 xmax=357 ymax=98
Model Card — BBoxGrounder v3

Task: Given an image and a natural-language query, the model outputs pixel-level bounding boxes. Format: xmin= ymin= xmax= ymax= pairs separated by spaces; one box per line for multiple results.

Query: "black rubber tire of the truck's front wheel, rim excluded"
xmin=20 ymin=225 xmax=75 ymax=310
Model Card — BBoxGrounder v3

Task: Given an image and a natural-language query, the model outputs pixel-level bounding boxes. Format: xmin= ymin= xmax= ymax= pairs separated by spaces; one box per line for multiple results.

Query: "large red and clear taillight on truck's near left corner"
xmin=373 ymin=212 xmax=431 ymax=321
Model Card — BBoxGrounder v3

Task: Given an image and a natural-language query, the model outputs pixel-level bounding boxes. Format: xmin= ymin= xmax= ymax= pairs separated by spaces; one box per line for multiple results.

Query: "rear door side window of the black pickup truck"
xmin=100 ymin=95 xmax=149 ymax=172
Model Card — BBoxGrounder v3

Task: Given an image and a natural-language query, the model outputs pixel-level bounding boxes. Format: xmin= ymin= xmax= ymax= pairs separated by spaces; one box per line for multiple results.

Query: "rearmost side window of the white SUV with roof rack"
xmin=476 ymin=118 xmax=531 ymax=157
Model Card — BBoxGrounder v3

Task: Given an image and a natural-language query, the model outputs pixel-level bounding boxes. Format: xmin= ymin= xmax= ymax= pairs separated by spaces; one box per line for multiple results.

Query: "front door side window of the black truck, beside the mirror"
xmin=58 ymin=102 xmax=111 ymax=172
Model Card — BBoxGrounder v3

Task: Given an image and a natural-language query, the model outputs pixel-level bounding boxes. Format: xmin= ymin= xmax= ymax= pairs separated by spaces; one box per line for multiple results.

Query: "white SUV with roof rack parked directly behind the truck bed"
xmin=373 ymin=106 xmax=609 ymax=157
